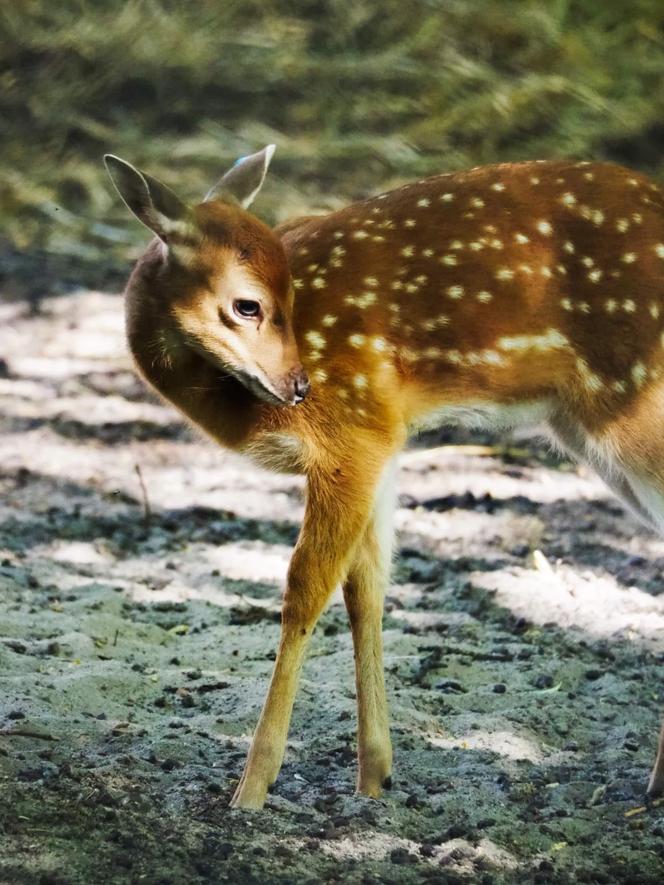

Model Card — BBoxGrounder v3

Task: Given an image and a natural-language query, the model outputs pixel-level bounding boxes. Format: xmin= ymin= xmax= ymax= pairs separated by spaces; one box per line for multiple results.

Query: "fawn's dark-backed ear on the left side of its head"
xmin=104 ymin=154 xmax=193 ymax=243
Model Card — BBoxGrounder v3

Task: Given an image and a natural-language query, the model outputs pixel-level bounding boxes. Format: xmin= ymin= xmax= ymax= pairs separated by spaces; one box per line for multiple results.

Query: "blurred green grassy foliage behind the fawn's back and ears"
xmin=0 ymin=0 xmax=664 ymax=297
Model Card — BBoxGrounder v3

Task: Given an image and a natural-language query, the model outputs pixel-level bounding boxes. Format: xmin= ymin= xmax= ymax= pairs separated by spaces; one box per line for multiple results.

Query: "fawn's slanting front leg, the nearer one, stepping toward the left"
xmin=231 ymin=456 xmax=390 ymax=808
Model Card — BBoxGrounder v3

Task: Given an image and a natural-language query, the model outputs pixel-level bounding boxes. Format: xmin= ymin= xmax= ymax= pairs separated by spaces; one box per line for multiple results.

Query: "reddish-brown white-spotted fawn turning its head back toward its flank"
xmin=106 ymin=145 xmax=664 ymax=808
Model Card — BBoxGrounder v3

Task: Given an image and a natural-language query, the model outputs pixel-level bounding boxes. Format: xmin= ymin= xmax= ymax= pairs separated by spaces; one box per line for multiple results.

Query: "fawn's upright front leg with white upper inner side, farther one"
xmin=343 ymin=459 xmax=396 ymax=798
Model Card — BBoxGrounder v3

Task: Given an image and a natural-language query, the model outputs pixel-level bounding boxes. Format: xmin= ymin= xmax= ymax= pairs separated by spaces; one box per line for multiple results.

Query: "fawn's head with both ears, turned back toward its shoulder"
xmin=104 ymin=145 xmax=309 ymax=405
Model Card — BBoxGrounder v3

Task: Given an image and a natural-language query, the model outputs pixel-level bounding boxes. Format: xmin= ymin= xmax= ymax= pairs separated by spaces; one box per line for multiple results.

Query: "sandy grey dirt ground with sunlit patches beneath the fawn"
xmin=0 ymin=293 xmax=664 ymax=885
